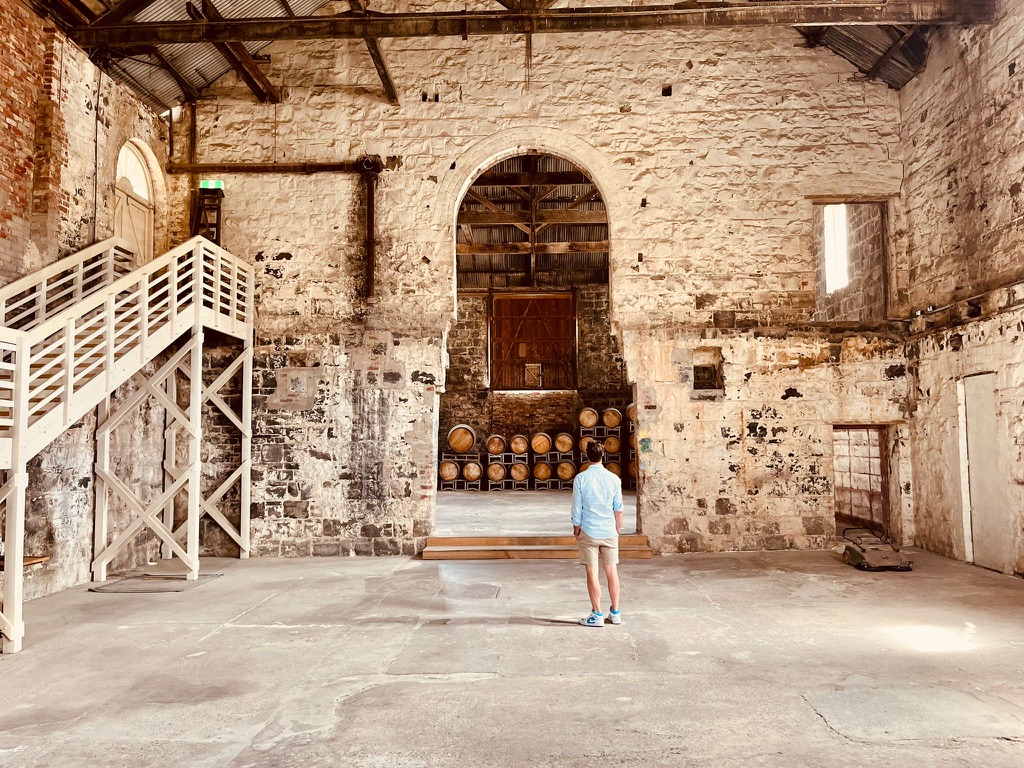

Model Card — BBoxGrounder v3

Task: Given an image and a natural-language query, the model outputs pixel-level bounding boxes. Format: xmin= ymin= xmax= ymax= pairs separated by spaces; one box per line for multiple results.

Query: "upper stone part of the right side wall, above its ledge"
xmin=900 ymin=0 xmax=1024 ymax=310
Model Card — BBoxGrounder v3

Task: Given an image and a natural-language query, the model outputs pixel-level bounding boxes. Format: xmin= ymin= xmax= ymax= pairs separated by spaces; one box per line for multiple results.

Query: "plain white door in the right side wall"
xmin=964 ymin=374 xmax=1014 ymax=570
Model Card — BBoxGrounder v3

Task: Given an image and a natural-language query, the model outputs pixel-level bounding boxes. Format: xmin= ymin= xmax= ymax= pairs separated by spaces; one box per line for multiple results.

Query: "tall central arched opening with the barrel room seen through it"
xmin=435 ymin=152 xmax=636 ymax=536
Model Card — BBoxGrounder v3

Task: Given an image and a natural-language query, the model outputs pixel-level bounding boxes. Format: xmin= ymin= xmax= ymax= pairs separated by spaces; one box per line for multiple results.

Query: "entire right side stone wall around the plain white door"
xmin=900 ymin=2 xmax=1024 ymax=572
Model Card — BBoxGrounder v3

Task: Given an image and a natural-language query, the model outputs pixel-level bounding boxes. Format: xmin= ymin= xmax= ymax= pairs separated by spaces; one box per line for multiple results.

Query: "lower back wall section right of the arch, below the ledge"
xmin=626 ymin=329 xmax=913 ymax=552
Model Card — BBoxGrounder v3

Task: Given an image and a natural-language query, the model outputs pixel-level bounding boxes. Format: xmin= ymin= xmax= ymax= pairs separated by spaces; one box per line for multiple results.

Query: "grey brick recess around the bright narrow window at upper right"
xmin=814 ymin=203 xmax=887 ymax=321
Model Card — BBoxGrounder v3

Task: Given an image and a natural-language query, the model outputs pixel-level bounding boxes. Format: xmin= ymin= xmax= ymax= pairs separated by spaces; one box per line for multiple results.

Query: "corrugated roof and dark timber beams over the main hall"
xmin=41 ymin=0 xmax=994 ymax=108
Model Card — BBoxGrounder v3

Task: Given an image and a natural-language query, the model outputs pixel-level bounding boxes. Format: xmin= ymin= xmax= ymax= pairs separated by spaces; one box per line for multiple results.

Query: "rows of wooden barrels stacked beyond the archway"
xmin=437 ymin=404 xmax=637 ymax=490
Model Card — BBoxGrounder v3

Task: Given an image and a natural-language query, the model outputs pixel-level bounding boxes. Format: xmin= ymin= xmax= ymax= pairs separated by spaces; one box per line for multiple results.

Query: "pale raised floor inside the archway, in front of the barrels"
xmin=434 ymin=490 xmax=637 ymax=536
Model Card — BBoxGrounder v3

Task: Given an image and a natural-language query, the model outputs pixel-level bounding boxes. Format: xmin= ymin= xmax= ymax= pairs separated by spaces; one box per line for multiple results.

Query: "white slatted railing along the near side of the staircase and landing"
xmin=0 ymin=237 xmax=255 ymax=448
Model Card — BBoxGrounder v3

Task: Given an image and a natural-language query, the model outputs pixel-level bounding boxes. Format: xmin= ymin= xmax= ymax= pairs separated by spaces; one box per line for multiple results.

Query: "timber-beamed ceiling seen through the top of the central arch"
xmin=456 ymin=154 xmax=608 ymax=292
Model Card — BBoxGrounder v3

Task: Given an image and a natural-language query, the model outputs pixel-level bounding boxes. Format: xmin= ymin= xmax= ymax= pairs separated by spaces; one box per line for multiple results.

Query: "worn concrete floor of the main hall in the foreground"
xmin=0 ymin=553 xmax=1024 ymax=768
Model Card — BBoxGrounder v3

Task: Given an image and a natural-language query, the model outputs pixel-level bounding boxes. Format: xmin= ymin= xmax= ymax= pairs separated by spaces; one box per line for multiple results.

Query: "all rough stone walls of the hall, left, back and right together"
xmin=0 ymin=0 xmax=1024 ymax=606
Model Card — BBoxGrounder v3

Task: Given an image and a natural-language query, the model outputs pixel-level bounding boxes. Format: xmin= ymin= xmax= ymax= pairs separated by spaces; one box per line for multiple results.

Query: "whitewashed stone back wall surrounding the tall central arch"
xmin=190 ymin=12 xmax=906 ymax=554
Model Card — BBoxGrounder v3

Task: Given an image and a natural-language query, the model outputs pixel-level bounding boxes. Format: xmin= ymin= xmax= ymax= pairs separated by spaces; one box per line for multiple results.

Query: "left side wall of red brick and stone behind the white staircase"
xmin=0 ymin=6 xmax=168 ymax=598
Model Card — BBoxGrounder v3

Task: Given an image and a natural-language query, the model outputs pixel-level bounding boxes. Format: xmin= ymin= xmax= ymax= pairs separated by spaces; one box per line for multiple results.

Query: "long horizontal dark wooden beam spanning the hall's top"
xmin=75 ymin=0 xmax=995 ymax=47
